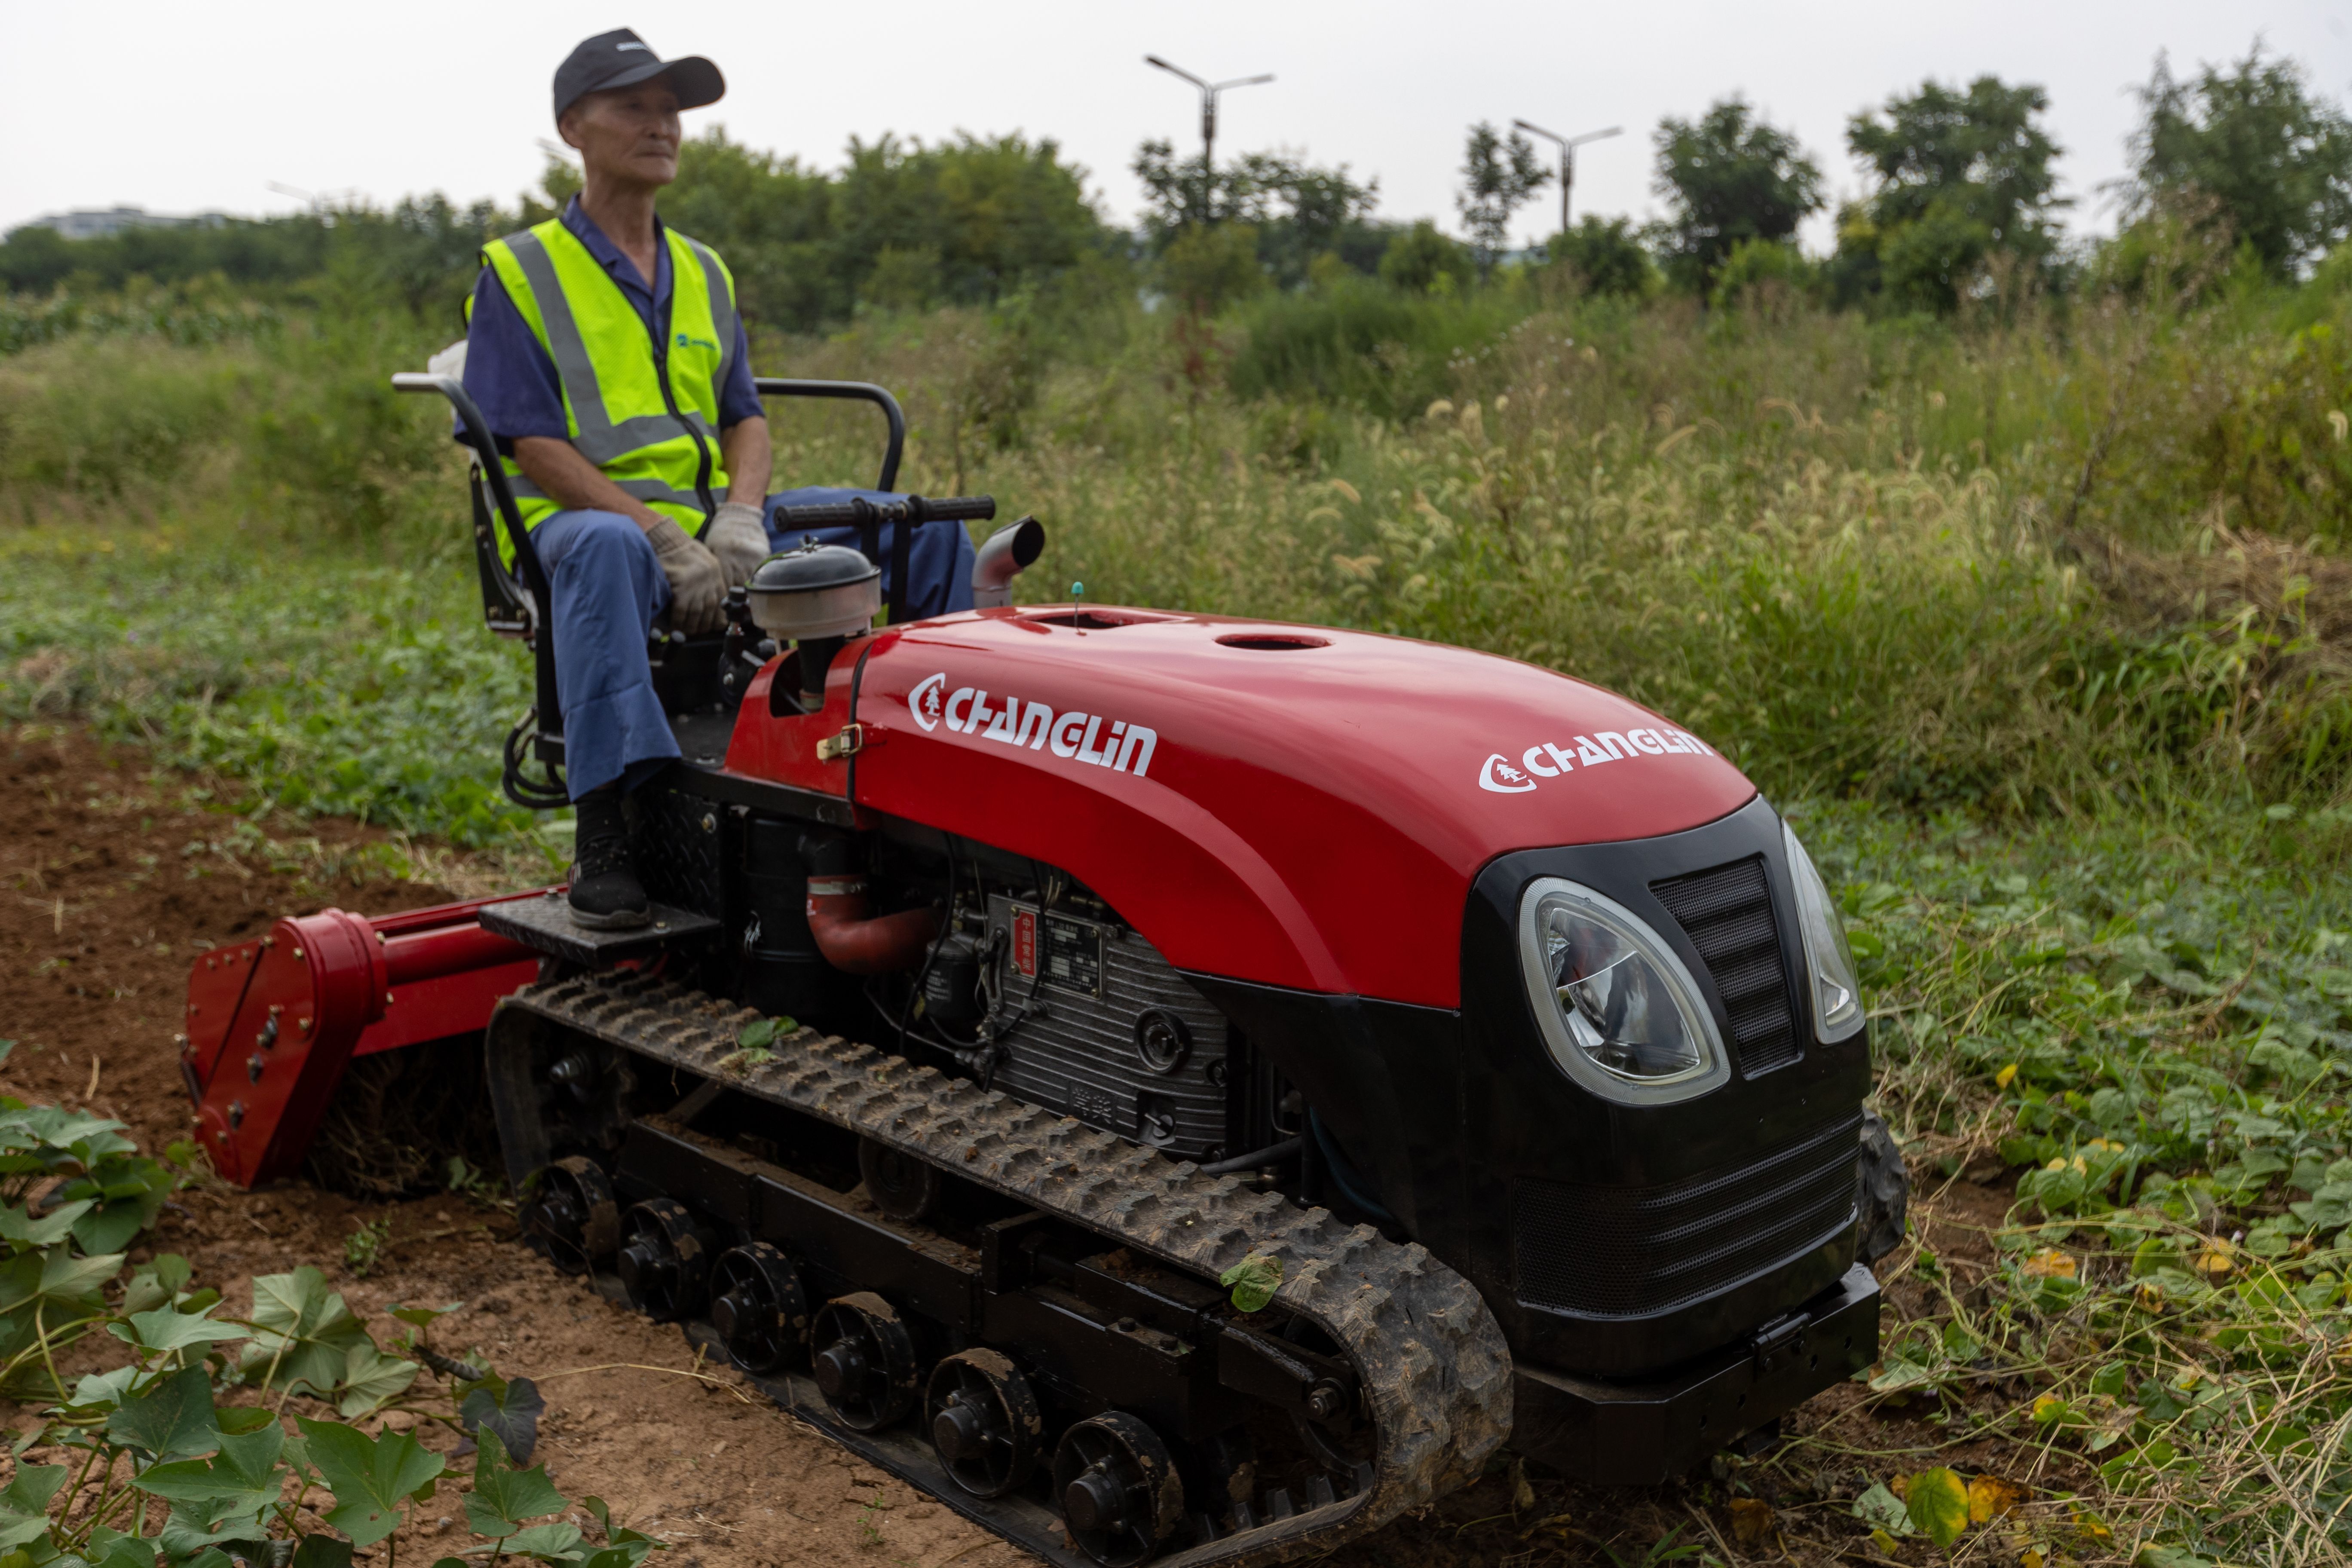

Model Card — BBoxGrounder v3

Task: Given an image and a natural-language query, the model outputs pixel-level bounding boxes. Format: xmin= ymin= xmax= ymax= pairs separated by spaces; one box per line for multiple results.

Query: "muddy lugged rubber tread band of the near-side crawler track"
xmin=492 ymin=973 xmax=1512 ymax=1568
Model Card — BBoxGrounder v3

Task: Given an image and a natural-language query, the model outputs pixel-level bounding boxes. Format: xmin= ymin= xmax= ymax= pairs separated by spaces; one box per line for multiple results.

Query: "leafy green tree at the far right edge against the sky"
xmin=2128 ymin=42 xmax=2352 ymax=277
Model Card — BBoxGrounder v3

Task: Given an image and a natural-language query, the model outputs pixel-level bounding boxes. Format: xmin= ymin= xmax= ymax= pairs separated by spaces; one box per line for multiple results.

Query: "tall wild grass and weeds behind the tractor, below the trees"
xmin=0 ymin=261 xmax=2352 ymax=832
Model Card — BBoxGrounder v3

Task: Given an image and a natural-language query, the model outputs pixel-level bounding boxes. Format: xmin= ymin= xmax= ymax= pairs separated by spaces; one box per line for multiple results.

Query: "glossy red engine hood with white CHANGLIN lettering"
xmin=743 ymin=609 xmax=1755 ymax=1006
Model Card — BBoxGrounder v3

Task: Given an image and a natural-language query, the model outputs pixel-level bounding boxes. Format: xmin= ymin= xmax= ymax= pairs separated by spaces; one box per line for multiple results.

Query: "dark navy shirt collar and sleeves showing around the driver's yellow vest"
xmin=466 ymin=195 xmax=764 ymax=456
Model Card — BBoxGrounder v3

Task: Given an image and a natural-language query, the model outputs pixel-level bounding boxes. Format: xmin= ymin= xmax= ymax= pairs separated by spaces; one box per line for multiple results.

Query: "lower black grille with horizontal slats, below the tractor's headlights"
xmin=1510 ymin=1117 xmax=1863 ymax=1317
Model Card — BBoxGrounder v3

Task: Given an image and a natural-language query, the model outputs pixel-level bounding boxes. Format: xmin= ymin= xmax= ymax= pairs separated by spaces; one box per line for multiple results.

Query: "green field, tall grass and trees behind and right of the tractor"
xmin=0 ymin=40 xmax=2352 ymax=1568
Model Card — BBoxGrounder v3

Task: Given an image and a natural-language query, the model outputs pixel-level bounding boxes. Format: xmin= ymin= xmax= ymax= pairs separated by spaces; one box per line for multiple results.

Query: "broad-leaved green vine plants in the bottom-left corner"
xmin=0 ymin=1063 xmax=661 ymax=1568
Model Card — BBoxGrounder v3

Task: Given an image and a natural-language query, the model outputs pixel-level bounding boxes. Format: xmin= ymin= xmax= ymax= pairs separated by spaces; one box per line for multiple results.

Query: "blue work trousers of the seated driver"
xmin=532 ymin=489 xmax=971 ymax=799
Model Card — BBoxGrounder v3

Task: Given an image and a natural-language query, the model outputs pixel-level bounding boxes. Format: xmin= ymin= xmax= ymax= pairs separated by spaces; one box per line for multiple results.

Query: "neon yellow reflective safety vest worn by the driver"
xmin=482 ymin=219 xmax=736 ymax=562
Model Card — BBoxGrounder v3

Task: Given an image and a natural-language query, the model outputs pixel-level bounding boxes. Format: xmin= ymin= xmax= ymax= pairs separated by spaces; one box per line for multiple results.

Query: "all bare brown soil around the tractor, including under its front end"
xmin=0 ymin=726 xmax=2022 ymax=1568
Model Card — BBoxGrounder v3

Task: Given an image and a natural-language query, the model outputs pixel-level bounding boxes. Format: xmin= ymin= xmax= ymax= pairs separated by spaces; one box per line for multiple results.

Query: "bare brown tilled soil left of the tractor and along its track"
xmin=0 ymin=729 xmax=1035 ymax=1568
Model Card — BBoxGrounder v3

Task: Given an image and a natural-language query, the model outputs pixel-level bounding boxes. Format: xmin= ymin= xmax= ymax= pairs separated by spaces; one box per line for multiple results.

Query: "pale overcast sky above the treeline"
xmin=14 ymin=0 xmax=2352 ymax=247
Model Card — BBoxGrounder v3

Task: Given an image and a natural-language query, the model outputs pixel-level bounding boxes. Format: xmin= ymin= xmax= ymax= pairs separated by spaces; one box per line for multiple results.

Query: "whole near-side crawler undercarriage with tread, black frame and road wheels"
xmin=487 ymin=973 xmax=1512 ymax=1568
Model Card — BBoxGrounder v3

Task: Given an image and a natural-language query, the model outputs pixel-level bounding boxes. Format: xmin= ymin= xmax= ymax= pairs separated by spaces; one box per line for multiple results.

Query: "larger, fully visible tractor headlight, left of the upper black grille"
xmin=1519 ymin=877 xmax=1731 ymax=1105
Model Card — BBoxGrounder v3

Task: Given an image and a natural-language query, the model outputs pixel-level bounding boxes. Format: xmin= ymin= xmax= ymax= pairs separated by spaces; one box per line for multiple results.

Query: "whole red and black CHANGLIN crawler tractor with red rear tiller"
xmin=184 ymin=376 xmax=1903 ymax=1566
